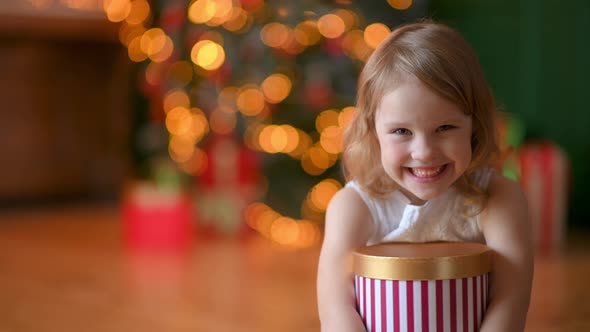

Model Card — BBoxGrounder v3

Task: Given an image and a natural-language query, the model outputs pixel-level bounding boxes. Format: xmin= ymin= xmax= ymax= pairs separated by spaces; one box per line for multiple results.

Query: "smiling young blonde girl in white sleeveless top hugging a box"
xmin=318 ymin=22 xmax=533 ymax=332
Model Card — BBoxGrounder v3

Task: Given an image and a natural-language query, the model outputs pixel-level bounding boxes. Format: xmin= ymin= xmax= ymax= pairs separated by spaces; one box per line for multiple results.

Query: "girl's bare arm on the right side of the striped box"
xmin=480 ymin=176 xmax=533 ymax=332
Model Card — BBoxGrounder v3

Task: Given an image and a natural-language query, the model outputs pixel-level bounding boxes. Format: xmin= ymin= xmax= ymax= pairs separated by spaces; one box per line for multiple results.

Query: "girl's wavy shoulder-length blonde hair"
xmin=342 ymin=21 xmax=498 ymax=205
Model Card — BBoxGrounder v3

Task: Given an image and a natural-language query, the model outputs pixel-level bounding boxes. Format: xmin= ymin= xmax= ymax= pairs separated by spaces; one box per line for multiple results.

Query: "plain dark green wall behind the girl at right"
xmin=429 ymin=0 xmax=590 ymax=228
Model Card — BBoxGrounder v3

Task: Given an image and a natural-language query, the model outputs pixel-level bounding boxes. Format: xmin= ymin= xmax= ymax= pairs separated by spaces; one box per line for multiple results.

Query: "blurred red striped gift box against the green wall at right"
xmin=518 ymin=141 xmax=570 ymax=254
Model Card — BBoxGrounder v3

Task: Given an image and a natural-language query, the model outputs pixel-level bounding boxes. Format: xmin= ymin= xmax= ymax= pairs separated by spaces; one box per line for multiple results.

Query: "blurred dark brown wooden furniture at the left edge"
xmin=0 ymin=12 xmax=132 ymax=201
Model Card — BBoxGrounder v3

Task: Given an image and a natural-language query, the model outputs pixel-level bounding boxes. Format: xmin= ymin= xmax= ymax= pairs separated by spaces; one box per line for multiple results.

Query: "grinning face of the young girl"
xmin=375 ymin=78 xmax=472 ymax=205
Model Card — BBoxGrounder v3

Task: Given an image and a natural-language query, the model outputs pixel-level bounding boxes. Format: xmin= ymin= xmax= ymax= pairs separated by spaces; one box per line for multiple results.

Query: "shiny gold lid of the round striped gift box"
xmin=352 ymin=242 xmax=492 ymax=280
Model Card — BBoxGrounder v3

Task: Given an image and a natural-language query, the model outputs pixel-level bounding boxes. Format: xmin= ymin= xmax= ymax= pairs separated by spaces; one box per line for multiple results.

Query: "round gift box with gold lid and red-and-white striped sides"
xmin=352 ymin=242 xmax=492 ymax=332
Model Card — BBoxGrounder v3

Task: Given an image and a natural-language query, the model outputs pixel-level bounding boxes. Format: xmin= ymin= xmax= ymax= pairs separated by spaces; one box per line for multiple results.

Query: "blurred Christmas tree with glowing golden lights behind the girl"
xmin=105 ymin=0 xmax=425 ymax=244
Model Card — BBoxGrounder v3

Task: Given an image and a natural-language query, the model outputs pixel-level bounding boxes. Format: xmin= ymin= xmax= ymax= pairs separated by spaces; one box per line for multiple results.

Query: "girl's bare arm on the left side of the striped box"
xmin=317 ymin=188 xmax=372 ymax=332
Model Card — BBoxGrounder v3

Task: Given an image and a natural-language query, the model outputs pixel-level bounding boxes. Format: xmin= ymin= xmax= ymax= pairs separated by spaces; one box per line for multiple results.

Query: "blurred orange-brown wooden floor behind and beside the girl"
xmin=0 ymin=206 xmax=590 ymax=332
